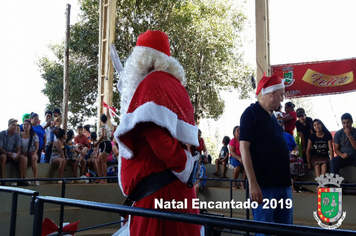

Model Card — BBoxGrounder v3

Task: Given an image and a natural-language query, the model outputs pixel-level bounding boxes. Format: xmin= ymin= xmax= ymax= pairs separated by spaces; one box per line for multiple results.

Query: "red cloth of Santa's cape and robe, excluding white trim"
xmin=118 ymin=72 xmax=200 ymax=236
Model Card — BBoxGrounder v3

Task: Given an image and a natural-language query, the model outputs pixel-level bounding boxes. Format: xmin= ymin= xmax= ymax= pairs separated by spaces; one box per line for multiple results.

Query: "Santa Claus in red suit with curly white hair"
xmin=114 ymin=30 xmax=201 ymax=236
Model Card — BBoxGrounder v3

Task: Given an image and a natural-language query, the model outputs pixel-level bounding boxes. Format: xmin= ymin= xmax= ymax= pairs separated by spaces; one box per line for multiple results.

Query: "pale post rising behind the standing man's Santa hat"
xmin=255 ymin=0 xmax=271 ymax=97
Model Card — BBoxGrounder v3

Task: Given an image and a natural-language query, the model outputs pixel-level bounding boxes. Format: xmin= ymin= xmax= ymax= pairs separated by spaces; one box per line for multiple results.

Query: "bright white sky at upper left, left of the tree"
xmin=0 ymin=0 xmax=79 ymax=130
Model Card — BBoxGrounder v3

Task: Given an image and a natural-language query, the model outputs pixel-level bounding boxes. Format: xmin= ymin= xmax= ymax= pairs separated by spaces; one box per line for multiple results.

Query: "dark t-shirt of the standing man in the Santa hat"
xmin=240 ymin=102 xmax=291 ymax=188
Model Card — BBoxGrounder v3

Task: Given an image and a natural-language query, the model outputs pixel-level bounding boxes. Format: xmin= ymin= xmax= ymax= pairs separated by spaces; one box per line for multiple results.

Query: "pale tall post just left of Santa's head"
xmin=97 ymin=0 xmax=116 ymax=130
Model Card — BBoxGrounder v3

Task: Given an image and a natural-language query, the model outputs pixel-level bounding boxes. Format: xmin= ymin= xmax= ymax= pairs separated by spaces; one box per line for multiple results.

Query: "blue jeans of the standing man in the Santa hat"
xmin=252 ymin=186 xmax=293 ymax=236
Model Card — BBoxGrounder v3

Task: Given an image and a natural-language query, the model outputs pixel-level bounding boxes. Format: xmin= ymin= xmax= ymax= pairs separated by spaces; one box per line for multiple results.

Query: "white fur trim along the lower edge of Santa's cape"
xmin=114 ymin=102 xmax=199 ymax=159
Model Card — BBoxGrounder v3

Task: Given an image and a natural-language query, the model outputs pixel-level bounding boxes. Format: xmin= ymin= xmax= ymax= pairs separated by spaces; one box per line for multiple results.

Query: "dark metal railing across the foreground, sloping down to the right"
xmin=33 ymin=196 xmax=356 ymax=236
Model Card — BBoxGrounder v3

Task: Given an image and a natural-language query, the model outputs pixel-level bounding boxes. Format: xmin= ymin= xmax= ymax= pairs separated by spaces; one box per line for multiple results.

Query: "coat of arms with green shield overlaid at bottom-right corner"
xmin=313 ymin=173 xmax=346 ymax=229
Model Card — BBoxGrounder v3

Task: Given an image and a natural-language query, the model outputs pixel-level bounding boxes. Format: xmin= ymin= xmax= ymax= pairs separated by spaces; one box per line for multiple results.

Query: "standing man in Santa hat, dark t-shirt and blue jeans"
xmin=240 ymin=74 xmax=293 ymax=235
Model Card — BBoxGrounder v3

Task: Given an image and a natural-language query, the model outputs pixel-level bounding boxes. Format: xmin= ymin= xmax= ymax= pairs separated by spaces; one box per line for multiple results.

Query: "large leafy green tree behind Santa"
xmin=38 ymin=0 xmax=251 ymax=126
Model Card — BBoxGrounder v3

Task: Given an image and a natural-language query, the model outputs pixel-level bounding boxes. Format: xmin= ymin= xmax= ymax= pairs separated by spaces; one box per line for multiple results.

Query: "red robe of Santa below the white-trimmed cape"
xmin=121 ymin=123 xmax=200 ymax=236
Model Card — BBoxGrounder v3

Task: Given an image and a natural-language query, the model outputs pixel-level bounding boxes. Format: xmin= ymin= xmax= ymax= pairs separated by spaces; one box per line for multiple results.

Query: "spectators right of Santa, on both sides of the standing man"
xmin=209 ymin=102 xmax=356 ymax=192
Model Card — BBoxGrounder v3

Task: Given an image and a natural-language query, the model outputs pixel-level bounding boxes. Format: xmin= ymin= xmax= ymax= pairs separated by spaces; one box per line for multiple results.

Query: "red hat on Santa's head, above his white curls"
xmin=136 ymin=30 xmax=171 ymax=57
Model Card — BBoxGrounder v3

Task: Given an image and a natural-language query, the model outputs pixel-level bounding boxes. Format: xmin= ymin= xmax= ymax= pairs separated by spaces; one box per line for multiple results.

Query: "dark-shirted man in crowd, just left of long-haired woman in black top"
xmin=295 ymin=108 xmax=313 ymax=163
